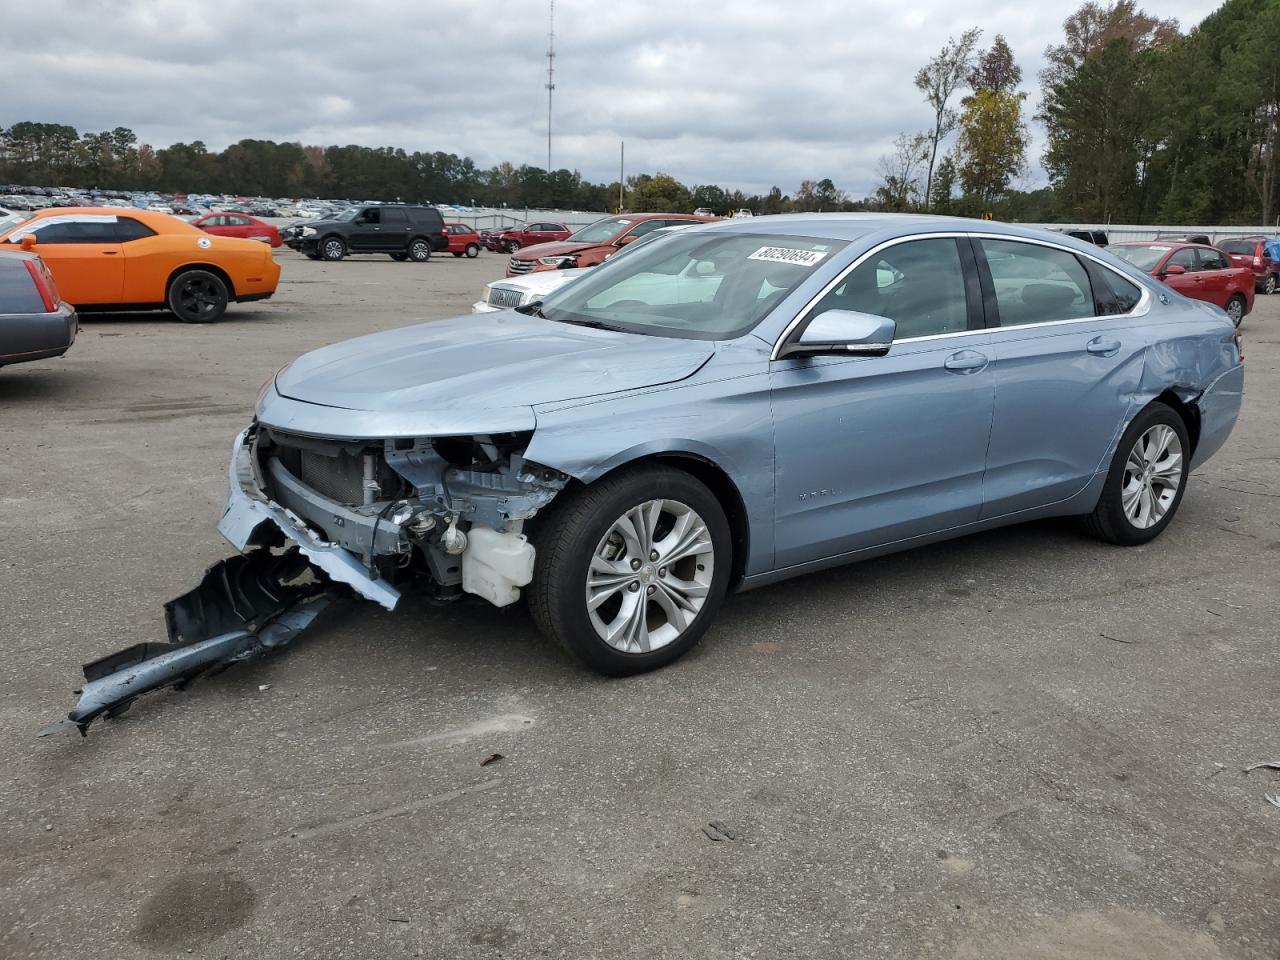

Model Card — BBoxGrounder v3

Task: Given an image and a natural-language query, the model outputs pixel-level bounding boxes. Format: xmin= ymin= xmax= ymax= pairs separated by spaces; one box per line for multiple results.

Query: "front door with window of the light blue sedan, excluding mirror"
xmin=771 ymin=238 xmax=995 ymax=568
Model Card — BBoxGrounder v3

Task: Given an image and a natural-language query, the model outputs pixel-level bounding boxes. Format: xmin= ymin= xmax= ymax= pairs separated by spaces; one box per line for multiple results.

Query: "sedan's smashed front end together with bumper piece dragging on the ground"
xmin=41 ymin=424 xmax=568 ymax=736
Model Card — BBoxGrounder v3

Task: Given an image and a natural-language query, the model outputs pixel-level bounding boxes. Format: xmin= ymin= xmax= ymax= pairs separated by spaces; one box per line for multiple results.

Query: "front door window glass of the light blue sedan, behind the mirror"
xmin=810 ymin=239 xmax=969 ymax=340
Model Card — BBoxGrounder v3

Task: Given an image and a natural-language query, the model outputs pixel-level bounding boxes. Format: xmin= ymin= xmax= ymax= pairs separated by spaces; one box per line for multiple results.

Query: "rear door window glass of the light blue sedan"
xmin=980 ymin=239 xmax=1094 ymax=326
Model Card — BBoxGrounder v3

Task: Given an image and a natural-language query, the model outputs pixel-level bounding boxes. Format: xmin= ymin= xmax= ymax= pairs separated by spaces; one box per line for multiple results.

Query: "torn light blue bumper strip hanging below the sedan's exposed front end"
xmin=218 ymin=429 xmax=399 ymax=611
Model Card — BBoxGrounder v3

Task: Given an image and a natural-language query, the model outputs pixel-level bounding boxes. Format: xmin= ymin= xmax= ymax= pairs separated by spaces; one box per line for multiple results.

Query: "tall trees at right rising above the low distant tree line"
xmin=874 ymin=0 xmax=1280 ymax=224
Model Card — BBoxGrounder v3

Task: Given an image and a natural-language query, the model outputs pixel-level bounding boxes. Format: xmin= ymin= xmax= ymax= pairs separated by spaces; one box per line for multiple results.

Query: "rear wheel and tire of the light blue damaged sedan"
xmin=1084 ymin=402 xmax=1192 ymax=547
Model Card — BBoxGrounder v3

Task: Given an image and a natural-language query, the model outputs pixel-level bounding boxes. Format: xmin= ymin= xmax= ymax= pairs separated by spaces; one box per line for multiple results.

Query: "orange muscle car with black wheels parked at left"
xmin=0 ymin=207 xmax=280 ymax=324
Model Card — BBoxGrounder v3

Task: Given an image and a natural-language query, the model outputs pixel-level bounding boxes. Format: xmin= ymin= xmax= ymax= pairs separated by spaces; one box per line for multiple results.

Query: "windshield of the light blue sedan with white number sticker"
xmin=541 ymin=230 xmax=846 ymax=340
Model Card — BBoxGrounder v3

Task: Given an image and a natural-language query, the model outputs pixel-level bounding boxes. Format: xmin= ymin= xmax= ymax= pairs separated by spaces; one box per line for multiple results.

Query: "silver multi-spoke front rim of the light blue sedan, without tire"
xmin=585 ymin=499 xmax=716 ymax=653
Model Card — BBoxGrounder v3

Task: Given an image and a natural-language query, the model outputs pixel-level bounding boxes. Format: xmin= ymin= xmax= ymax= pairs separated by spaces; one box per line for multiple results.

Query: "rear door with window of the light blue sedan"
xmin=973 ymin=237 xmax=1144 ymax=520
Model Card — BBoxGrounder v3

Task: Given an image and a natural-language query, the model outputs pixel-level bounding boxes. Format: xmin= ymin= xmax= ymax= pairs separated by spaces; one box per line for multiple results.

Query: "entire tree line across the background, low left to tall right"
xmin=0 ymin=0 xmax=1280 ymax=224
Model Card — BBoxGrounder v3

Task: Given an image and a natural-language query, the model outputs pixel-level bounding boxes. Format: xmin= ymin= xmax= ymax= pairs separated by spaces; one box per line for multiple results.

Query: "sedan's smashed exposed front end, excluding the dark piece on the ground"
xmin=218 ymin=424 xmax=568 ymax=609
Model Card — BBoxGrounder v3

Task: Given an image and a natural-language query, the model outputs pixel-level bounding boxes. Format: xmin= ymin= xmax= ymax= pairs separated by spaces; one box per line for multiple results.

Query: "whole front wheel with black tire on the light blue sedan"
xmin=529 ymin=466 xmax=732 ymax=677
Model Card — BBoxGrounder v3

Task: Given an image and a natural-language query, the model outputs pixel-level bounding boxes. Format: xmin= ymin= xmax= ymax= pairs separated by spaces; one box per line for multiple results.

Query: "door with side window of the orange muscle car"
xmin=12 ymin=214 xmax=124 ymax=306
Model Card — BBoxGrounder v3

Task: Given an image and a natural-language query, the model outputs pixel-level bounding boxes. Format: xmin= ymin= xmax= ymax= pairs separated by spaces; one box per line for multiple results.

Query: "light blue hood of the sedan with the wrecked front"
xmin=275 ymin=310 xmax=714 ymax=431
